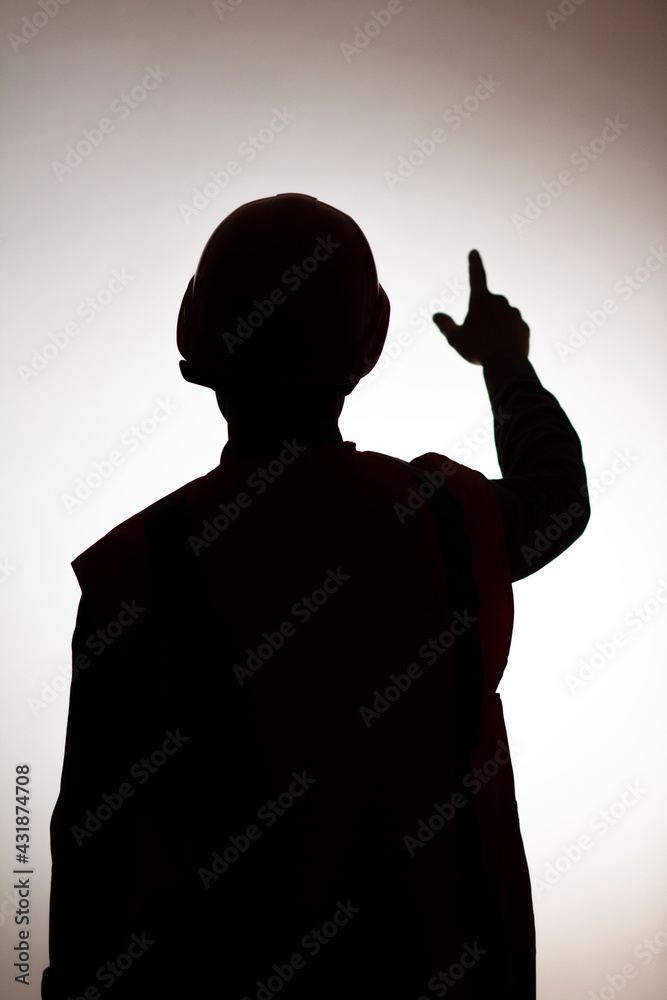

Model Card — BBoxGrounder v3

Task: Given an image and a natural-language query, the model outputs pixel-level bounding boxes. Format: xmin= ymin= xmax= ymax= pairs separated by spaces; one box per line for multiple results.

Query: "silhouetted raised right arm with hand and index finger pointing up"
xmin=433 ymin=250 xmax=590 ymax=581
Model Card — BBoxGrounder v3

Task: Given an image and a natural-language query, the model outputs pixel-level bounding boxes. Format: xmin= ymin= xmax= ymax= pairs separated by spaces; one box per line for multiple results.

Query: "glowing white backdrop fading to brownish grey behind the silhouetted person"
xmin=0 ymin=0 xmax=667 ymax=1000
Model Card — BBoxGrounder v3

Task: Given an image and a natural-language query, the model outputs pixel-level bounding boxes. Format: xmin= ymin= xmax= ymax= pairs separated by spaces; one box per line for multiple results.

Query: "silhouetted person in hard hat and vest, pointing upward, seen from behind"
xmin=42 ymin=194 xmax=589 ymax=1000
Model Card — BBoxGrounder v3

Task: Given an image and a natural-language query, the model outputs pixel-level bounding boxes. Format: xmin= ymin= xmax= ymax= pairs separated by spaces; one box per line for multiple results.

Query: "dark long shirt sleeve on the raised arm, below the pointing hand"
xmin=484 ymin=352 xmax=590 ymax=582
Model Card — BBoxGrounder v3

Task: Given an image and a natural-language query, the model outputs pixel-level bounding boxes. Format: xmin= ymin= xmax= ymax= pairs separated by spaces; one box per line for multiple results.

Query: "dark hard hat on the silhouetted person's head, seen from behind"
xmin=177 ymin=194 xmax=389 ymax=392
